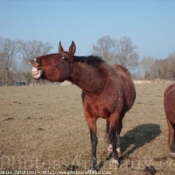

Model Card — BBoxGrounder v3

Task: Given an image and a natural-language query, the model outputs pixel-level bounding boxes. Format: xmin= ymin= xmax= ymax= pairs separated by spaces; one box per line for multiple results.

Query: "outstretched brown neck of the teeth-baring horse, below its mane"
xmin=69 ymin=62 xmax=106 ymax=94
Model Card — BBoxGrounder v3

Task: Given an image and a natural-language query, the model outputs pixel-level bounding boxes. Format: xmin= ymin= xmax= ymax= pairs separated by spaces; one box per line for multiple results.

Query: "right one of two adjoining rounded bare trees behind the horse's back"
xmin=114 ymin=37 xmax=139 ymax=69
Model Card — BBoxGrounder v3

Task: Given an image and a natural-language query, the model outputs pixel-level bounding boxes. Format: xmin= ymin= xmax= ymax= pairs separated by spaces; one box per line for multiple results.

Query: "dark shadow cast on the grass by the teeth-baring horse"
xmin=98 ymin=123 xmax=161 ymax=169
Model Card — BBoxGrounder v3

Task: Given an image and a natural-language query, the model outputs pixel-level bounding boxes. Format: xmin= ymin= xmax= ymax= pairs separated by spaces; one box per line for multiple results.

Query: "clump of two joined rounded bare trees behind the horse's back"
xmin=92 ymin=35 xmax=139 ymax=69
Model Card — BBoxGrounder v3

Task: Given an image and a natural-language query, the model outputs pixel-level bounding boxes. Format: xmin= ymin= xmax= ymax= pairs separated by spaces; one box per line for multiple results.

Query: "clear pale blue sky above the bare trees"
xmin=0 ymin=0 xmax=175 ymax=59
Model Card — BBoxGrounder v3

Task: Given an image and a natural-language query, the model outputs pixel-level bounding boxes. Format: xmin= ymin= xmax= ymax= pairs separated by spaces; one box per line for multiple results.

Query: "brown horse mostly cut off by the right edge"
xmin=164 ymin=84 xmax=175 ymax=158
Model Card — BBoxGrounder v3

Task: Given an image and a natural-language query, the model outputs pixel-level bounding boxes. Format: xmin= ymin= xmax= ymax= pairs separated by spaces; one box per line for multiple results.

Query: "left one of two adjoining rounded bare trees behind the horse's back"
xmin=92 ymin=35 xmax=115 ymax=62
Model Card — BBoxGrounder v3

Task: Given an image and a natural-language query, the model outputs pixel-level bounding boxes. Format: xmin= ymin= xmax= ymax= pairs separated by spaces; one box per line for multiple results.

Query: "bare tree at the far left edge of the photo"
xmin=0 ymin=38 xmax=21 ymax=85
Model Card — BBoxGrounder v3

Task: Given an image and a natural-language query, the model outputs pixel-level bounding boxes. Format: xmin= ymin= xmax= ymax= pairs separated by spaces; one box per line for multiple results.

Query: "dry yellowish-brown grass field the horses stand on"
xmin=0 ymin=83 xmax=175 ymax=175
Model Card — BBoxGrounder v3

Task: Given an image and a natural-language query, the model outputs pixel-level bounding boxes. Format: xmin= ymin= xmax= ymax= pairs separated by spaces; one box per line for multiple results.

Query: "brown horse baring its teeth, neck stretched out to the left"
xmin=30 ymin=41 xmax=136 ymax=170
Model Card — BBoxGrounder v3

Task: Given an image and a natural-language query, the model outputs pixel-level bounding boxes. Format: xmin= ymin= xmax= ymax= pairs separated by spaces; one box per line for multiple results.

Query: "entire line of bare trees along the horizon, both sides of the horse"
xmin=0 ymin=35 xmax=175 ymax=86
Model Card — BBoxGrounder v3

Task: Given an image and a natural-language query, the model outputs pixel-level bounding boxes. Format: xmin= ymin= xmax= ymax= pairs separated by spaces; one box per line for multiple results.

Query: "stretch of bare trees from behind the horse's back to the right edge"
xmin=92 ymin=35 xmax=175 ymax=80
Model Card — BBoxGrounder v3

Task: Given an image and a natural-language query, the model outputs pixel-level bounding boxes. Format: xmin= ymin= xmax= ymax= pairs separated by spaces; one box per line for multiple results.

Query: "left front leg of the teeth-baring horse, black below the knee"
xmin=85 ymin=113 xmax=98 ymax=171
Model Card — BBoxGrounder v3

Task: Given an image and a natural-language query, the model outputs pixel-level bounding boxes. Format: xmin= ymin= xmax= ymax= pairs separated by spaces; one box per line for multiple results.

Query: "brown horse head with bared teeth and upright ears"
xmin=29 ymin=41 xmax=76 ymax=82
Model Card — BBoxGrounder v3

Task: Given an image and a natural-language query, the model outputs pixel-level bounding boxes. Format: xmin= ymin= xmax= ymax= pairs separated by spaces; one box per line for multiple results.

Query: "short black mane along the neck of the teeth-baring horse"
xmin=74 ymin=55 xmax=104 ymax=63
